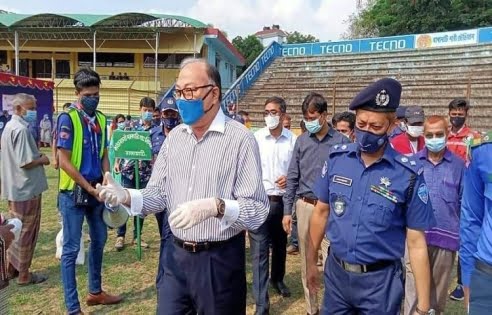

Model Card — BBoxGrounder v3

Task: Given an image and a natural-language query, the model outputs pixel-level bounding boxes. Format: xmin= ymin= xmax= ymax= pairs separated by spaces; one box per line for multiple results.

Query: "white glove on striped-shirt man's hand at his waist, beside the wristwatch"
xmin=169 ymin=198 xmax=217 ymax=230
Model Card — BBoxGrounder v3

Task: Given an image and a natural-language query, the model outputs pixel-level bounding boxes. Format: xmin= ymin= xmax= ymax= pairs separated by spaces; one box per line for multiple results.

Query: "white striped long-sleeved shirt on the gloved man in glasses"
xmin=125 ymin=110 xmax=269 ymax=242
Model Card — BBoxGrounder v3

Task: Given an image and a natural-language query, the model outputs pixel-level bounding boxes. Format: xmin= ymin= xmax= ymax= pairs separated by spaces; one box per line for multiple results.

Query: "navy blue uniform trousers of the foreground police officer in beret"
xmin=321 ymin=253 xmax=403 ymax=315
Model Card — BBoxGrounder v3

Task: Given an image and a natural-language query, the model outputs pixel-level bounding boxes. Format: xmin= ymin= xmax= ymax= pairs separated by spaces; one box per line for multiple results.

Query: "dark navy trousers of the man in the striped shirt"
xmin=157 ymin=233 xmax=246 ymax=315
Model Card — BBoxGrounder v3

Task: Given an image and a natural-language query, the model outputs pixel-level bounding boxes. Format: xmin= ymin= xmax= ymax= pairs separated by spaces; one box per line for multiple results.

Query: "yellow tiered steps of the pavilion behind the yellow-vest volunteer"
xmin=53 ymin=79 xmax=160 ymax=117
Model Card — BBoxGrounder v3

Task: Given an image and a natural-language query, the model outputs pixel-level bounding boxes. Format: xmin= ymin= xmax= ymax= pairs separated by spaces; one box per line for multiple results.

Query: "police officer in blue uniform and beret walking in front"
xmin=307 ymin=78 xmax=435 ymax=315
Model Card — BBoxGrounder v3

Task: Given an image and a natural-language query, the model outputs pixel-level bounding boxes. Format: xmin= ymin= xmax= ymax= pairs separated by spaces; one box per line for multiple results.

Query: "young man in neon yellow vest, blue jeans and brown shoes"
xmin=57 ymin=69 xmax=122 ymax=314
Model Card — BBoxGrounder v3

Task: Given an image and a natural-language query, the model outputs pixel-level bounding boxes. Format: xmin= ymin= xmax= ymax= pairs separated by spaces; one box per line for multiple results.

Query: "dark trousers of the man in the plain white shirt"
xmin=248 ymin=201 xmax=287 ymax=314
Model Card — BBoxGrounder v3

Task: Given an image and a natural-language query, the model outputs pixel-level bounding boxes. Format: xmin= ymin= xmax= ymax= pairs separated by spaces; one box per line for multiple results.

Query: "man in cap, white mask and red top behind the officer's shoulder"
xmin=391 ymin=106 xmax=425 ymax=156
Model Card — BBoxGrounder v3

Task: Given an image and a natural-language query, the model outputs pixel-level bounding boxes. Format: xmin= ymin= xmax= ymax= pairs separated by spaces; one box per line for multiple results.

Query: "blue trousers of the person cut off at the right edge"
xmin=469 ymin=261 xmax=492 ymax=315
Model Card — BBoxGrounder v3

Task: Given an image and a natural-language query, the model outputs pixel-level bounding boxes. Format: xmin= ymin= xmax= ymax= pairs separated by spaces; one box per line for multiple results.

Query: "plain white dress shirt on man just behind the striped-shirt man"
xmin=255 ymin=127 xmax=297 ymax=196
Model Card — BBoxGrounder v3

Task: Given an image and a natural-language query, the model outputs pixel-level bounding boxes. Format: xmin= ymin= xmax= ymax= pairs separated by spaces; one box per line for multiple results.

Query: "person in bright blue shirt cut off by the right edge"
xmin=459 ymin=131 xmax=492 ymax=315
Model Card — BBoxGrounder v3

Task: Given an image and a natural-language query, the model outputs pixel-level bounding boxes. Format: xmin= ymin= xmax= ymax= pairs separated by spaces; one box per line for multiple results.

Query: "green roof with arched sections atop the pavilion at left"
xmin=0 ymin=12 xmax=207 ymax=28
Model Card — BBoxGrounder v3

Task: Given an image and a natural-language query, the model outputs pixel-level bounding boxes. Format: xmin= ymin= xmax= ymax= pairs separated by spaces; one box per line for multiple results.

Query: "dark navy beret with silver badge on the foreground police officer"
xmin=349 ymin=78 xmax=401 ymax=112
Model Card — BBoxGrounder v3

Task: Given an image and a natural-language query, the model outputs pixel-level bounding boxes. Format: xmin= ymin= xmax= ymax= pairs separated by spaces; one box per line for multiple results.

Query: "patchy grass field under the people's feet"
xmin=7 ymin=150 xmax=465 ymax=315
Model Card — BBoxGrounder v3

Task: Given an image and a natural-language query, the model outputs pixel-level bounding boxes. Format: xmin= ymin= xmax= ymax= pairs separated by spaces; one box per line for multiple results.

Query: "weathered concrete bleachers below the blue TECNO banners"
xmin=238 ymin=44 xmax=492 ymax=130
